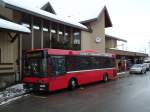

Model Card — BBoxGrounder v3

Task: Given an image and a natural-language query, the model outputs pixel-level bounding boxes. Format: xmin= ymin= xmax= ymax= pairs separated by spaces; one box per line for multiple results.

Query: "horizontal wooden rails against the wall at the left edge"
xmin=0 ymin=63 xmax=14 ymax=74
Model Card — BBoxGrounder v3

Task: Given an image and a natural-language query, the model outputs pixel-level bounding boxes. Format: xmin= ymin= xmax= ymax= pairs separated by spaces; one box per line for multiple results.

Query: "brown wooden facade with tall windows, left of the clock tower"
xmin=0 ymin=0 xmax=82 ymax=88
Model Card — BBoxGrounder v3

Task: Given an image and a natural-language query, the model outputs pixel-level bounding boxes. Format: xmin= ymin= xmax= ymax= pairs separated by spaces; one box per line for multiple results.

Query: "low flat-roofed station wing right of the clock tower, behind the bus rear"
xmin=105 ymin=35 xmax=148 ymax=72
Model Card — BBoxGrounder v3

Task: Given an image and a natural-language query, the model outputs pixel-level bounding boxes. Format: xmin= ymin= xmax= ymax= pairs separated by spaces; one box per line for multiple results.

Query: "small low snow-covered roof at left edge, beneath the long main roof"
xmin=0 ymin=18 xmax=30 ymax=33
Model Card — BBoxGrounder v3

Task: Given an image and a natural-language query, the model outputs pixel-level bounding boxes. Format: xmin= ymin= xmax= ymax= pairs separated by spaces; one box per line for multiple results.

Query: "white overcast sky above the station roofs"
xmin=27 ymin=0 xmax=150 ymax=53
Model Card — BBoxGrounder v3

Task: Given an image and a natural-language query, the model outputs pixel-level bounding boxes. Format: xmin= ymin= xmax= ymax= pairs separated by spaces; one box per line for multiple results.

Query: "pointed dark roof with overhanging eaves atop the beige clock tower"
xmin=80 ymin=6 xmax=113 ymax=28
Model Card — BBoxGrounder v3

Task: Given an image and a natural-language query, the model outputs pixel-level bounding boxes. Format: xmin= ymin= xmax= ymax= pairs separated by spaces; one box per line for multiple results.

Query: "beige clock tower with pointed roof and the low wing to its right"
xmin=80 ymin=6 xmax=148 ymax=72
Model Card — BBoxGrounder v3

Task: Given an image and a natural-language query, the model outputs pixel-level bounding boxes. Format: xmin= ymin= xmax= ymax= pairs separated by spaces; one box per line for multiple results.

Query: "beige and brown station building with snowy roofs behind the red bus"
xmin=0 ymin=0 xmax=146 ymax=88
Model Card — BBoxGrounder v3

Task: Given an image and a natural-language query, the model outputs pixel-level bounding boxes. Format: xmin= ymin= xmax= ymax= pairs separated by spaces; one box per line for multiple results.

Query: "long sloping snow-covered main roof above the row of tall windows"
xmin=2 ymin=0 xmax=88 ymax=30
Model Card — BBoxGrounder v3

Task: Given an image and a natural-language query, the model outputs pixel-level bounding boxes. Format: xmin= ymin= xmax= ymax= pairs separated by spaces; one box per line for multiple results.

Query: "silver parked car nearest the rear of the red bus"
xmin=129 ymin=64 xmax=146 ymax=74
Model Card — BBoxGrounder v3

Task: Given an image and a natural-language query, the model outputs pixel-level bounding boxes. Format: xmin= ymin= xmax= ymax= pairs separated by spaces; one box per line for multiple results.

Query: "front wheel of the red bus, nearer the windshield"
xmin=68 ymin=77 xmax=78 ymax=90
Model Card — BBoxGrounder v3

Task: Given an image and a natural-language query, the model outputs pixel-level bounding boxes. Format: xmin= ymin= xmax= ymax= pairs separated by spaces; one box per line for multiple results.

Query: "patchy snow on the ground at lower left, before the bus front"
xmin=0 ymin=84 xmax=26 ymax=105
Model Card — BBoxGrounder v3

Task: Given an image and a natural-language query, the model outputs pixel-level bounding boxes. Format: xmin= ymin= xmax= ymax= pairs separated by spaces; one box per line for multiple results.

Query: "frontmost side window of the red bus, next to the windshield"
xmin=51 ymin=56 xmax=66 ymax=76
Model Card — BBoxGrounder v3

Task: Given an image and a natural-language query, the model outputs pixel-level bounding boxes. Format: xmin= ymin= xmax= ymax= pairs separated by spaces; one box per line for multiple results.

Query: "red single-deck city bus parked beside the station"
xmin=23 ymin=49 xmax=117 ymax=91
